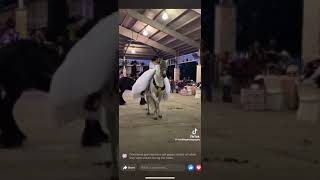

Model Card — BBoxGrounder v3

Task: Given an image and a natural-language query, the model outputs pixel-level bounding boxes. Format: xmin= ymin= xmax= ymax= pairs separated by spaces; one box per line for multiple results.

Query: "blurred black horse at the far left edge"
xmin=0 ymin=40 xmax=62 ymax=147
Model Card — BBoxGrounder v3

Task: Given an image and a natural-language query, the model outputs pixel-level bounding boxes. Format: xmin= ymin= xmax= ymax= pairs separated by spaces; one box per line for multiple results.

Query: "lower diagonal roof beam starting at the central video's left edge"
xmin=119 ymin=26 xmax=177 ymax=55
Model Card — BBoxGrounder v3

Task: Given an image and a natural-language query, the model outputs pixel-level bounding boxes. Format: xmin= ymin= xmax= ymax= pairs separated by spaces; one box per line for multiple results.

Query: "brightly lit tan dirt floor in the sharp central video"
xmin=119 ymin=91 xmax=201 ymax=160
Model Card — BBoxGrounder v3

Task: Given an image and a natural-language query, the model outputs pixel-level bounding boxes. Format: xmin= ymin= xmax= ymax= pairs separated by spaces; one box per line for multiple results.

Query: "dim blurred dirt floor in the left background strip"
xmin=0 ymin=92 xmax=110 ymax=180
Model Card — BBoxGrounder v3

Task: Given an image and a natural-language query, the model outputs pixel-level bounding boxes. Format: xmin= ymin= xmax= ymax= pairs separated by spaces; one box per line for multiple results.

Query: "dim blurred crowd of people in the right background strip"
xmin=217 ymin=39 xmax=294 ymax=81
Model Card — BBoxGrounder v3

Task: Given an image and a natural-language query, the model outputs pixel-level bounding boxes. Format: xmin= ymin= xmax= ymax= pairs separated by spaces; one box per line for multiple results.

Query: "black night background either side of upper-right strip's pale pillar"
xmin=202 ymin=0 xmax=303 ymax=56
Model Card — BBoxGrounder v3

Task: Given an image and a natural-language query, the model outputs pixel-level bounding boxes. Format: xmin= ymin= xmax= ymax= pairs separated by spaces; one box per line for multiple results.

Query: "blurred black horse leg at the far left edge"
xmin=0 ymin=89 xmax=26 ymax=148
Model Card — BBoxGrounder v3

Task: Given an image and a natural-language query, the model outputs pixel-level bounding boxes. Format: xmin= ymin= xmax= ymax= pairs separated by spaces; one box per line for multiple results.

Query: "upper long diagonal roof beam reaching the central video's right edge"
xmin=126 ymin=9 xmax=200 ymax=48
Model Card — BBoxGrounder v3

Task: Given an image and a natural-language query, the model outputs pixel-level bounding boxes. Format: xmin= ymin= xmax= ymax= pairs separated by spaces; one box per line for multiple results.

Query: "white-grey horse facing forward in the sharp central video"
xmin=146 ymin=61 xmax=167 ymax=120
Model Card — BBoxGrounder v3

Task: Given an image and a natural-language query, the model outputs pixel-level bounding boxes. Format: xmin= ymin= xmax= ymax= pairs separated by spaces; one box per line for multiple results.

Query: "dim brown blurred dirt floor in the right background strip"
xmin=202 ymin=92 xmax=320 ymax=180
